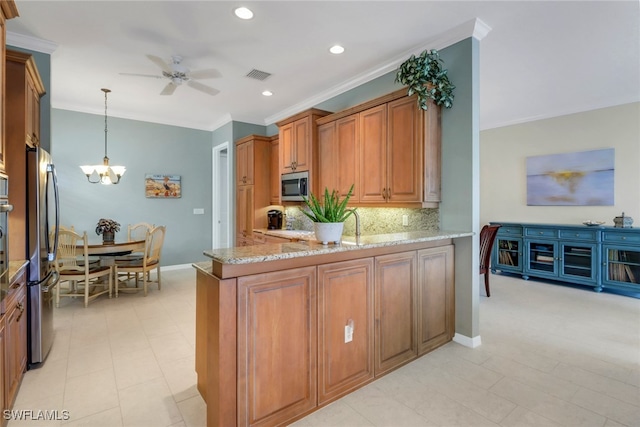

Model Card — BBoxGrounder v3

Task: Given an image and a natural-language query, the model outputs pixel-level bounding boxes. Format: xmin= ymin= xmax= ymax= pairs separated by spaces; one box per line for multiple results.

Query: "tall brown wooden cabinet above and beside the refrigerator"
xmin=4 ymin=50 xmax=45 ymax=260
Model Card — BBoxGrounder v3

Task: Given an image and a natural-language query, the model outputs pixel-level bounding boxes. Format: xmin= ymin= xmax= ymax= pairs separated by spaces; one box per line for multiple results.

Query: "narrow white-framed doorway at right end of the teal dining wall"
xmin=211 ymin=141 xmax=233 ymax=249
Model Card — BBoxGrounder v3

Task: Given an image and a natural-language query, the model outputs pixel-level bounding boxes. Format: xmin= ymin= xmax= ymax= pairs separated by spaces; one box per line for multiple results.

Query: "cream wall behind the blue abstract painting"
xmin=480 ymin=103 xmax=640 ymax=226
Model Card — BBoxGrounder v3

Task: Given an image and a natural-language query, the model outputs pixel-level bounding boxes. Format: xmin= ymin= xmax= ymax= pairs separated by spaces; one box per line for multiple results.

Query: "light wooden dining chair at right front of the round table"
xmin=115 ymin=225 xmax=166 ymax=297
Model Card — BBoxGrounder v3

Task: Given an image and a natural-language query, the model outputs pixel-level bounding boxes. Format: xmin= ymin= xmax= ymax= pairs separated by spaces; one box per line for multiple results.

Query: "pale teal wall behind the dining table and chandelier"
xmin=51 ymin=109 xmax=211 ymax=265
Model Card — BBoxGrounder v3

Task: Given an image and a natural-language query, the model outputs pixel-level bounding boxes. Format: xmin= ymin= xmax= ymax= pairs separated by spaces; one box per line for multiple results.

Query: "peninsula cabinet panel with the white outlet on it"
xmin=318 ymin=258 xmax=374 ymax=404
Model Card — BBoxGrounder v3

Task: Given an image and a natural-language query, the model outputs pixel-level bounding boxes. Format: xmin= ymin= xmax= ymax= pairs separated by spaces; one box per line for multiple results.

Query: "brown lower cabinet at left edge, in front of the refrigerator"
xmin=4 ymin=269 xmax=27 ymax=408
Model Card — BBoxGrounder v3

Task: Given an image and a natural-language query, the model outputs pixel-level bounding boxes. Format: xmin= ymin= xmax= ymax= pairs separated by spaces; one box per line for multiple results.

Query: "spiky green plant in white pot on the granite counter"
xmin=300 ymin=184 xmax=355 ymax=245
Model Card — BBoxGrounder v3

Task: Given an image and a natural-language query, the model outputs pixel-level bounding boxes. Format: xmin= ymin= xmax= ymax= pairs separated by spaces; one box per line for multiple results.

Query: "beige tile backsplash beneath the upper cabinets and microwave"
xmin=283 ymin=206 xmax=440 ymax=236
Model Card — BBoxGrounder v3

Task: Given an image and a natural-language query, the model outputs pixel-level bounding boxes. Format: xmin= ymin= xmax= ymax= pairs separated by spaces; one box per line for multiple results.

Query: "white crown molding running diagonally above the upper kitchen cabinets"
xmin=264 ymin=18 xmax=491 ymax=125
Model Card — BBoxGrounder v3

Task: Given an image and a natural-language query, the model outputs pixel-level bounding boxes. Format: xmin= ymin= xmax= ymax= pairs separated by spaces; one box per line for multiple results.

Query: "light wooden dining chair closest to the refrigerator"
xmin=54 ymin=229 xmax=113 ymax=307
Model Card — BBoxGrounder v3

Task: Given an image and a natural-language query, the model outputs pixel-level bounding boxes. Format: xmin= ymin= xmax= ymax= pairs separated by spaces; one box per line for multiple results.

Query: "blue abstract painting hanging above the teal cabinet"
xmin=527 ymin=148 xmax=614 ymax=206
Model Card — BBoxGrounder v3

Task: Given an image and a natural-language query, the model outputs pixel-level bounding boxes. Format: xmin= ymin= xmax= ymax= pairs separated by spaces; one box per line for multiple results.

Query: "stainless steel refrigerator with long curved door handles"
xmin=26 ymin=148 xmax=60 ymax=369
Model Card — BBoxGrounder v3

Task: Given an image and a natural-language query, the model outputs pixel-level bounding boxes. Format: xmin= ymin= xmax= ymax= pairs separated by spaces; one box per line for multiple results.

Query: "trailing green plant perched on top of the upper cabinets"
xmin=395 ymin=49 xmax=456 ymax=110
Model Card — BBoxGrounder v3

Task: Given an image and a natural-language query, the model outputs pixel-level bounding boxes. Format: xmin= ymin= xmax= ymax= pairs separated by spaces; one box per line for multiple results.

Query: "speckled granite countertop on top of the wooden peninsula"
xmin=204 ymin=230 xmax=473 ymax=264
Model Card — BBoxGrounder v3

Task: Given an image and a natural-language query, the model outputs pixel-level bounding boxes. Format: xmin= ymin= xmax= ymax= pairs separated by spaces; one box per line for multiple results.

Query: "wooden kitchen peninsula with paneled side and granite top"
xmin=194 ymin=231 xmax=473 ymax=427
